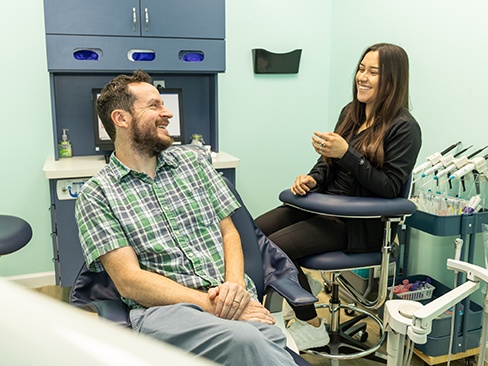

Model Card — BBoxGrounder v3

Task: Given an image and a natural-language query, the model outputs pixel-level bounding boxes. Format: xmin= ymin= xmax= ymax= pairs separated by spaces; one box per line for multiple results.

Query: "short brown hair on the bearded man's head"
xmin=97 ymin=70 xmax=151 ymax=142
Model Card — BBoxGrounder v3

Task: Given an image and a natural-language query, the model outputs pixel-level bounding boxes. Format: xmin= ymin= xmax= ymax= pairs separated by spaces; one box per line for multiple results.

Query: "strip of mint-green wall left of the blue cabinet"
xmin=0 ymin=0 xmax=54 ymax=276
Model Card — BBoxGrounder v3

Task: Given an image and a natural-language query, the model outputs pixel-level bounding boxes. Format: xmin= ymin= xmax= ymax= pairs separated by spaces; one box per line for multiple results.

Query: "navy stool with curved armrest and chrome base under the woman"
xmin=279 ymin=179 xmax=416 ymax=365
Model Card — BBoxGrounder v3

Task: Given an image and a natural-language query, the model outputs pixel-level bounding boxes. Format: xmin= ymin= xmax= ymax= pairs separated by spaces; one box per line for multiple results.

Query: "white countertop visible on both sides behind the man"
xmin=42 ymin=151 xmax=239 ymax=179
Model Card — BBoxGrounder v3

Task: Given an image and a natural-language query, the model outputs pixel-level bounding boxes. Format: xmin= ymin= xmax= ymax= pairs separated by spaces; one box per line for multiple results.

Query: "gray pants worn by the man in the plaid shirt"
xmin=130 ymin=304 xmax=295 ymax=366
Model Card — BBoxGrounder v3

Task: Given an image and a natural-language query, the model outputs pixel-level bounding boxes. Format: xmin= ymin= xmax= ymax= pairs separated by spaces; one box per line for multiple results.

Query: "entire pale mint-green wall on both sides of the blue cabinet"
xmin=0 ymin=0 xmax=488 ymax=306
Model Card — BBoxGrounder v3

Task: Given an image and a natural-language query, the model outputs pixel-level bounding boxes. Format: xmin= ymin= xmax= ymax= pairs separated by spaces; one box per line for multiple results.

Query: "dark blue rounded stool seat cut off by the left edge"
xmin=0 ymin=215 xmax=32 ymax=257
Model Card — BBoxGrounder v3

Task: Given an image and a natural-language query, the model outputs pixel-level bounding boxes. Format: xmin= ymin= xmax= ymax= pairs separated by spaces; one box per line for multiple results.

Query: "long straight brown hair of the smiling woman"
xmin=335 ymin=43 xmax=408 ymax=167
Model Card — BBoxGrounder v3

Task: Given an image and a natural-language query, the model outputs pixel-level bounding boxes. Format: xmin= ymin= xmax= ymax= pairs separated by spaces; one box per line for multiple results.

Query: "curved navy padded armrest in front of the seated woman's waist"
xmin=279 ymin=189 xmax=417 ymax=219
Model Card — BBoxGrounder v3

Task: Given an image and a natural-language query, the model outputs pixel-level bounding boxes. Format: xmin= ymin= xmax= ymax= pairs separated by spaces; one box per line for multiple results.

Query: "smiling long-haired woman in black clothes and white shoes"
xmin=256 ymin=43 xmax=421 ymax=350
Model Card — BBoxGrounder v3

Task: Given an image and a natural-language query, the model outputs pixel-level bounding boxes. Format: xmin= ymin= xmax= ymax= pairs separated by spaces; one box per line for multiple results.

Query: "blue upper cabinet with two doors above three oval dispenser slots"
xmin=44 ymin=0 xmax=225 ymax=73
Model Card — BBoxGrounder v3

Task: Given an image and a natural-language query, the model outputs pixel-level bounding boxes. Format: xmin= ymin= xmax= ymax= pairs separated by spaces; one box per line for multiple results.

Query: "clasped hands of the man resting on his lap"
xmin=208 ymin=282 xmax=275 ymax=324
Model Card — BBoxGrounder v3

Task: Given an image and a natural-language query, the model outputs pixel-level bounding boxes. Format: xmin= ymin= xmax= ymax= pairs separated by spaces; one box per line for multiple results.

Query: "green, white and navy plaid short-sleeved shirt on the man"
xmin=75 ymin=148 xmax=256 ymax=308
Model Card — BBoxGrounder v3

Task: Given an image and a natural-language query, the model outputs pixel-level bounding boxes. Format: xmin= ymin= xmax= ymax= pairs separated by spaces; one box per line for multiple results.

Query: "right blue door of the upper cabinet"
xmin=140 ymin=0 xmax=225 ymax=39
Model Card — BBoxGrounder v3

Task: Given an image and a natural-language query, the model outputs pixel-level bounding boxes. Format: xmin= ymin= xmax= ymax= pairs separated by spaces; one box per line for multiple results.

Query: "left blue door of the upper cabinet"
xmin=44 ymin=0 xmax=141 ymax=36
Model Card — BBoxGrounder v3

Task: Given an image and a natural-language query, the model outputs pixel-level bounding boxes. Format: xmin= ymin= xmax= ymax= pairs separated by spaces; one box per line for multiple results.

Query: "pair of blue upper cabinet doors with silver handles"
xmin=44 ymin=0 xmax=225 ymax=39
